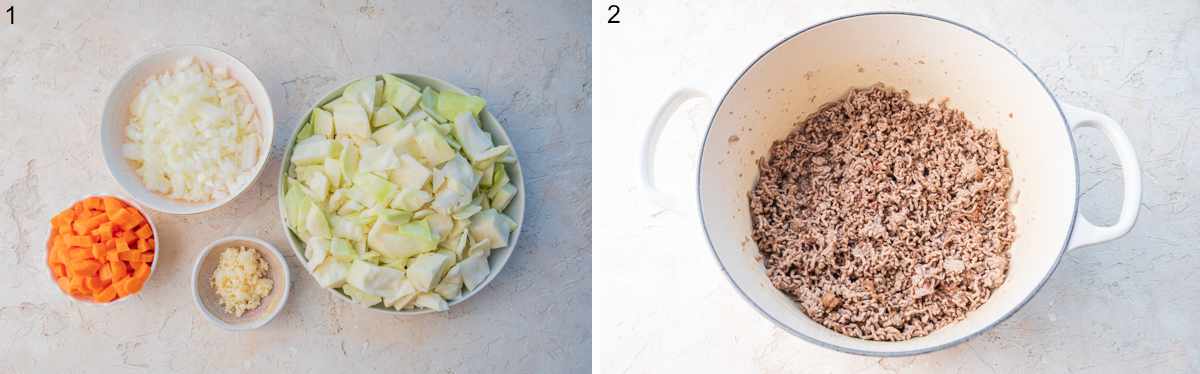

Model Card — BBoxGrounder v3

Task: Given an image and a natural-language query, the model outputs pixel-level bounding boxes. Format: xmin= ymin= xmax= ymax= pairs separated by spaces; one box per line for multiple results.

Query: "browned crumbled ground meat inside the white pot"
xmin=750 ymin=85 xmax=1014 ymax=340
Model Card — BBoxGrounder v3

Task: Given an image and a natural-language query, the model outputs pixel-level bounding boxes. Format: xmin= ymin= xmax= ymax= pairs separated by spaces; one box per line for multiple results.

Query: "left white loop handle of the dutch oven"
xmin=640 ymin=89 xmax=712 ymax=212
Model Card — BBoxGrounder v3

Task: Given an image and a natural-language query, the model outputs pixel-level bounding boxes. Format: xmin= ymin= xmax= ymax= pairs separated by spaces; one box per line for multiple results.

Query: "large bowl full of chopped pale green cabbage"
xmin=278 ymin=73 xmax=524 ymax=314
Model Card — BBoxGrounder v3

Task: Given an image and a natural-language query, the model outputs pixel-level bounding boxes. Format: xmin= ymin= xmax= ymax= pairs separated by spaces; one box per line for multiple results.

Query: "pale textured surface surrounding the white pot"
xmin=593 ymin=0 xmax=1200 ymax=373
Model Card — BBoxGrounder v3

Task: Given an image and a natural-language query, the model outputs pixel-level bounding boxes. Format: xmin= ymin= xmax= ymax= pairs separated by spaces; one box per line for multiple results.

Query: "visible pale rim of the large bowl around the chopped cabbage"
xmin=277 ymin=73 xmax=526 ymax=315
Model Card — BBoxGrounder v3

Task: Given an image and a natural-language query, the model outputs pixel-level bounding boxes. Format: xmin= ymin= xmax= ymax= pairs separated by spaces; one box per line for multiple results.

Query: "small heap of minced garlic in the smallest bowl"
xmin=212 ymin=247 xmax=274 ymax=316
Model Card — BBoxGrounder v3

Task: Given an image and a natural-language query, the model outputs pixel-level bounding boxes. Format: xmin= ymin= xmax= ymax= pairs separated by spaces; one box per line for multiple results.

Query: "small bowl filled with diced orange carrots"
xmin=46 ymin=195 xmax=158 ymax=304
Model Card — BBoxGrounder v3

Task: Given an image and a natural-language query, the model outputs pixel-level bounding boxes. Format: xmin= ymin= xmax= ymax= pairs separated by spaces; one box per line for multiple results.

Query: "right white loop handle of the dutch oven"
xmin=1058 ymin=103 xmax=1141 ymax=249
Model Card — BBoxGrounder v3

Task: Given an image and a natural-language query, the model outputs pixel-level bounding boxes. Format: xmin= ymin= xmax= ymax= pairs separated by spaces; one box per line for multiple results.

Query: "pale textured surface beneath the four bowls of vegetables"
xmin=0 ymin=0 xmax=592 ymax=373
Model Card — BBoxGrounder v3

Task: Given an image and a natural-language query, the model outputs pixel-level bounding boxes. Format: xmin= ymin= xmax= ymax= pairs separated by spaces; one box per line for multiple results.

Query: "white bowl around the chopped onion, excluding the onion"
xmin=100 ymin=46 xmax=275 ymax=215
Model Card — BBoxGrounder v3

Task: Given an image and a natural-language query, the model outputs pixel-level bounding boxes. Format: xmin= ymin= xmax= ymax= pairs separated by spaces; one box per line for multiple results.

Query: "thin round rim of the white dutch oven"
xmin=696 ymin=11 xmax=1079 ymax=357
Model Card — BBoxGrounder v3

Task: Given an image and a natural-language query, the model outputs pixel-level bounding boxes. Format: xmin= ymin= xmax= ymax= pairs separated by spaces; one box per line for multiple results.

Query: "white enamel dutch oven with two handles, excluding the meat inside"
xmin=642 ymin=13 xmax=1141 ymax=356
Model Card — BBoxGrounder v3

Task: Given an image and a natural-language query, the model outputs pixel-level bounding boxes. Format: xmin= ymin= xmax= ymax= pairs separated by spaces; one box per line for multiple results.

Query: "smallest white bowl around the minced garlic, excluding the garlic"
xmin=192 ymin=236 xmax=292 ymax=331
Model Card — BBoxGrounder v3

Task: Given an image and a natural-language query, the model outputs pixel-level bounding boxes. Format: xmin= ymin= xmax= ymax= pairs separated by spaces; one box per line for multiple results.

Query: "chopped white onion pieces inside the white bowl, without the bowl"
xmin=121 ymin=58 xmax=262 ymax=201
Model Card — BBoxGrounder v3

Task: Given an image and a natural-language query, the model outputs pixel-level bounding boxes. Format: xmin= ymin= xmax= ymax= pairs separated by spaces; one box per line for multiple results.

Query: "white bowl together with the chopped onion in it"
xmin=100 ymin=46 xmax=275 ymax=215
